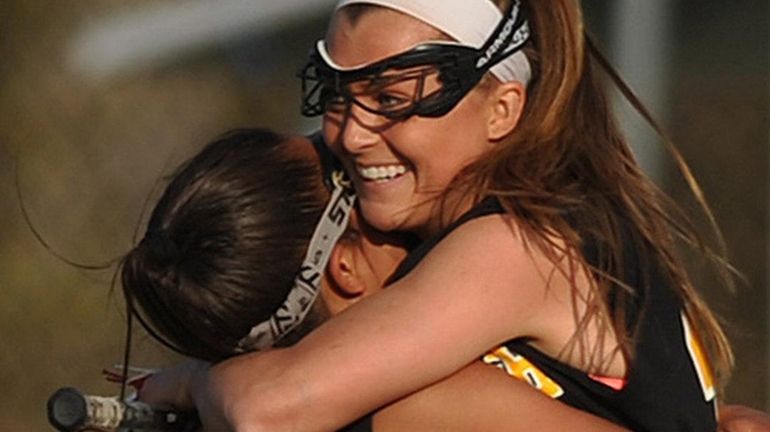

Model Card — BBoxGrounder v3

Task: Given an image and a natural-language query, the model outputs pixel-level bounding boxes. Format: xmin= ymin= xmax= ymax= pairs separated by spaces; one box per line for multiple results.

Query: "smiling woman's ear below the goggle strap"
xmin=487 ymin=81 xmax=527 ymax=141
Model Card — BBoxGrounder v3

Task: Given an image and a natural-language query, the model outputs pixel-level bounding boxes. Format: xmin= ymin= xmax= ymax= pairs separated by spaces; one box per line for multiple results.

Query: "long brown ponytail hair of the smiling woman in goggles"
xmin=455 ymin=0 xmax=733 ymax=387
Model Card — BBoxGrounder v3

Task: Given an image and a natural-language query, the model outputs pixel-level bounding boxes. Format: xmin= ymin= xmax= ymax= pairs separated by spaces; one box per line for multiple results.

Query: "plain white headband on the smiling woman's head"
xmin=336 ymin=0 xmax=532 ymax=86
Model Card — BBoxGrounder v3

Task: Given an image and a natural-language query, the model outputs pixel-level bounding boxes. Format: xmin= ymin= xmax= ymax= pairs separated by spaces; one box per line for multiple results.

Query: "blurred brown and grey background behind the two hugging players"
xmin=0 ymin=0 xmax=770 ymax=432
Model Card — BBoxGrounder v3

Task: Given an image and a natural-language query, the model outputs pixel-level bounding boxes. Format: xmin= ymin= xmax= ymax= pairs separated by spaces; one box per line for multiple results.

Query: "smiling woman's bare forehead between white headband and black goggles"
xmin=326 ymin=7 xmax=446 ymax=67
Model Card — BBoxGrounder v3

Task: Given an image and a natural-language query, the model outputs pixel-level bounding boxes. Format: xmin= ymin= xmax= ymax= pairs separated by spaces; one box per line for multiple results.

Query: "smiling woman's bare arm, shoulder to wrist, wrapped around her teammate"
xmin=174 ymin=216 xmax=571 ymax=431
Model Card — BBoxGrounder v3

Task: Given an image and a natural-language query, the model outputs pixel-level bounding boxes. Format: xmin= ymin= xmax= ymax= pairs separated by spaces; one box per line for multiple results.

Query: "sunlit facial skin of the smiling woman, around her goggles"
xmin=323 ymin=9 xmax=494 ymax=240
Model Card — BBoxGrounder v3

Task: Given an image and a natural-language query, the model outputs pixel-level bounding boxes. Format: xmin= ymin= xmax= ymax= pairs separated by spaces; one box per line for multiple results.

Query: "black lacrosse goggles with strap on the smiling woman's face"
xmin=299 ymin=0 xmax=530 ymax=121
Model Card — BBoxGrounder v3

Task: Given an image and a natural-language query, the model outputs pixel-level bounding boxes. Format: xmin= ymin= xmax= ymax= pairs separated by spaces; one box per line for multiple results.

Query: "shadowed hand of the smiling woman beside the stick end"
xmin=138 ymin=360 xmax=210 ymax=410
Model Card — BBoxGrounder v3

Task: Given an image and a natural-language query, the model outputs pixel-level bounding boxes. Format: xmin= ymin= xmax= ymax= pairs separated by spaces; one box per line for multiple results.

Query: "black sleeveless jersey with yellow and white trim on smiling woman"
xmin=340 ymin=198 xmax=717 ymax=432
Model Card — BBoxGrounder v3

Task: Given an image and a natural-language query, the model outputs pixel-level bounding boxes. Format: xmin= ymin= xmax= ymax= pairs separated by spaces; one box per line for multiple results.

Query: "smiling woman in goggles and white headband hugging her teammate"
xmin=144 ymin=0 xmax=732 ymax=431
